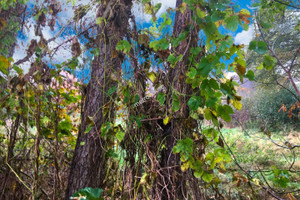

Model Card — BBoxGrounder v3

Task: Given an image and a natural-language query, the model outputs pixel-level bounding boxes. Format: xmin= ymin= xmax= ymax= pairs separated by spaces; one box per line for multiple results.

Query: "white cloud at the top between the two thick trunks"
xmin=132 ymin=0 xmax=176 ymax=22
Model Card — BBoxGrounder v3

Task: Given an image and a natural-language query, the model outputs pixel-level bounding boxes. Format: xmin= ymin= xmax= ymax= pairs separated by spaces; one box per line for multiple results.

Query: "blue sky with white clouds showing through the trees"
xmin=13 ymin=0 xmax=254 ymax=81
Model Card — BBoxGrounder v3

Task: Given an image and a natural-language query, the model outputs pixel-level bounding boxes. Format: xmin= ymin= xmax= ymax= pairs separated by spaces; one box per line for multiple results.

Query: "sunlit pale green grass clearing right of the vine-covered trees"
xmin=211 ymin=128 xmax=300 ymax=198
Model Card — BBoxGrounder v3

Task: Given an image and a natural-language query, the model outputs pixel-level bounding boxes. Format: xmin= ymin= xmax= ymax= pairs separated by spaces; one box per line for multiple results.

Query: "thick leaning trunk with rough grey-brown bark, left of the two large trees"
xmin=65 ymin=0 xmax=132 ymax=200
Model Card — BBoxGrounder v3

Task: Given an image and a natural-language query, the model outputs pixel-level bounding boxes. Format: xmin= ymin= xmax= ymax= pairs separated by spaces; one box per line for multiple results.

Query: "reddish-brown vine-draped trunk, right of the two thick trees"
xmin=159 ymin=0 xmax=204 ymax=200
